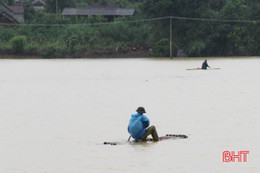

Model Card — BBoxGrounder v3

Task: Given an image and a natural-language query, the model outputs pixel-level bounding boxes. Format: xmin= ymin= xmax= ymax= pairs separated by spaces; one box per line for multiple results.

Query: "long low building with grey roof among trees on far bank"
xmin=61 ymin=3 xmax=135 ymax=21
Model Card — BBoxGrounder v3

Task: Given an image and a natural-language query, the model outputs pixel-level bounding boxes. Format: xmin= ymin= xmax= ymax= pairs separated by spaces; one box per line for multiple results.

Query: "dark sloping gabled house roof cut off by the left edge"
xmin=0 ymin=3 xmax=21 ymax=25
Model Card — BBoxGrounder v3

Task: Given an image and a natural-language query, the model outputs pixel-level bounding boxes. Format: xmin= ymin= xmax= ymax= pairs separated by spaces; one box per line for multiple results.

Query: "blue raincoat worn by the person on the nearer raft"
xmin=128 ymin=113 xmax=150 ymax=140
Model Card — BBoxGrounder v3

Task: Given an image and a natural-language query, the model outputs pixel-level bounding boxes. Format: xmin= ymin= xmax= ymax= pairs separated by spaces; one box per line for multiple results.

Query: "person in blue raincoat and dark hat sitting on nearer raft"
xmin=128 ymin=107 xmax=158 ymax=141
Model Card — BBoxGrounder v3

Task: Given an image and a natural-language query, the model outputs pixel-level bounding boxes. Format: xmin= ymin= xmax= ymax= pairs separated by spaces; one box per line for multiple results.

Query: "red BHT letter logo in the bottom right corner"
xmin=222 ymin=151 xmax=249 ymax=162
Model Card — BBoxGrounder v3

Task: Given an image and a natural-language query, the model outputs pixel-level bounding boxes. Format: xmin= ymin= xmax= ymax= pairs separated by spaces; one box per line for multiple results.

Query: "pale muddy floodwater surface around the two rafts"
xmin=0 ymin=57 xmax=260 ymax=173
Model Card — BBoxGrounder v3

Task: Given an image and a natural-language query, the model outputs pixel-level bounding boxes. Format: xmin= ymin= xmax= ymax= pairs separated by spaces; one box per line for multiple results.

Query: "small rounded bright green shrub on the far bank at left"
xmin=10 ymin=35 xmax=27 ymax=53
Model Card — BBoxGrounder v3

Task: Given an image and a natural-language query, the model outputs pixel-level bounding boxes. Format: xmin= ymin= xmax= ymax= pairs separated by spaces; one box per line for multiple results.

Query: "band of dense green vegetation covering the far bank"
xmin=0 ymin=0 xmax=260 ymax=58
